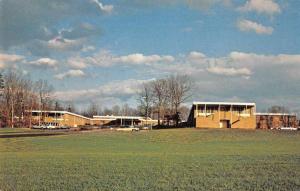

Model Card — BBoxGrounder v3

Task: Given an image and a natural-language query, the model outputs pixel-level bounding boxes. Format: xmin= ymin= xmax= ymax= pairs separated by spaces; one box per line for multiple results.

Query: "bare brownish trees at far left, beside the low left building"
xmin=0 ymin=71 xmax=54 ymax=127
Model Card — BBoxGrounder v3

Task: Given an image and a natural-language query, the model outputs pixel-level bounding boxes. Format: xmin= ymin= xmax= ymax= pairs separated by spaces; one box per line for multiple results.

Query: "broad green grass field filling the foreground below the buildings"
xmin=0 ymin=129 xmax=300 ymax=191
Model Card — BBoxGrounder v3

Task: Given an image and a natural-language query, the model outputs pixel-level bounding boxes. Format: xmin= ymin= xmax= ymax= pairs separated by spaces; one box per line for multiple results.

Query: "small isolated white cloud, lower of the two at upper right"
xmin=237 ymin=19 xmax=273 ymax=35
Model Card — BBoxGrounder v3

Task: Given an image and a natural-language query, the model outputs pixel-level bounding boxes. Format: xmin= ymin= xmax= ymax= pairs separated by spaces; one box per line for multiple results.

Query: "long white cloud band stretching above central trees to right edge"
xmin=61 ymin=51 xmax=300 ymax=80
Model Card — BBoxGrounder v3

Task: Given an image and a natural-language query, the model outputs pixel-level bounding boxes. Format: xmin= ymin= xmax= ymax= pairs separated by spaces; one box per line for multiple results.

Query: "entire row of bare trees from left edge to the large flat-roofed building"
xmin=0 ymin=71 xmax=191 ymax=127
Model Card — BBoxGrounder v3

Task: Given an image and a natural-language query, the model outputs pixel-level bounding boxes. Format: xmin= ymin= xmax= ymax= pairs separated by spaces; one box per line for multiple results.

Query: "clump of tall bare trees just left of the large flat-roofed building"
xmin=138 ymin=75 xmax=193 ymax=126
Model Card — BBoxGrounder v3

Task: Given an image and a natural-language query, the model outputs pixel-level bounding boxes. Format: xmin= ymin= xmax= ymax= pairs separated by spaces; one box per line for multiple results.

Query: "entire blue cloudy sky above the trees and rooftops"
xmin=0 ymin=0 xmax=300 ymax=112
